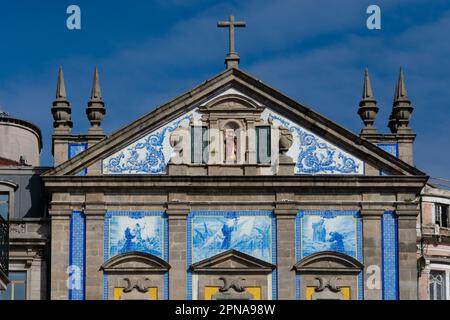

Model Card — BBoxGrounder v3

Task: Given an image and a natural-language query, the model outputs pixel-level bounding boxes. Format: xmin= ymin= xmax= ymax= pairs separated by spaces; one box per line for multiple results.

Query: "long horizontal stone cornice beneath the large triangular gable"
xmin=43 ymin=175 xmax=428 ymax=193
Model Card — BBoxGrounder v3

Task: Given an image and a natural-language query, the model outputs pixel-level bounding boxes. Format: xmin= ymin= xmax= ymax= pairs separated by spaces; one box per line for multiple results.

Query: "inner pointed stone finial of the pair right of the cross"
xmin=358 ymin=68 xmax=379 ymax=134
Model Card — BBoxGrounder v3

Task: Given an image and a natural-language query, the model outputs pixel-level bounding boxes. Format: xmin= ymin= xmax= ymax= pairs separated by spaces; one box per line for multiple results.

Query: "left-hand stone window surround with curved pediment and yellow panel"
xmin=100 ymin=252 xmax=170 ymax=300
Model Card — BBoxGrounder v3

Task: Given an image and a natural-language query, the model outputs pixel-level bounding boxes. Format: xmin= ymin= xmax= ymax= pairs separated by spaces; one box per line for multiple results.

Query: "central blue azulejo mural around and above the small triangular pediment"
xmin=187 ymin=211 xmax=277 ymax=299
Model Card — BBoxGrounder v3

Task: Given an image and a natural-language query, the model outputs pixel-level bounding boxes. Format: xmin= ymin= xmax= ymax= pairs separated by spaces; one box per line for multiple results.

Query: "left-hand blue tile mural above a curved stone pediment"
xmin=105 ymin=212 xmax=167 ymax=260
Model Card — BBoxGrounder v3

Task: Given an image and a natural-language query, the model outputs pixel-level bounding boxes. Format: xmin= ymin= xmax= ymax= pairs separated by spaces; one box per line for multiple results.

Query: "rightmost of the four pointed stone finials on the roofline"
xmin=388 ymin=68 xmax=414 ymax=133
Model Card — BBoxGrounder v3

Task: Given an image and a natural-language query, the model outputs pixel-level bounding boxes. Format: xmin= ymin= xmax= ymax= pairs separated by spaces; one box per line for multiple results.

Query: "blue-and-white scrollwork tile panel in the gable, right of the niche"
xmin=262 ymin=109 xmax=364 ymax=175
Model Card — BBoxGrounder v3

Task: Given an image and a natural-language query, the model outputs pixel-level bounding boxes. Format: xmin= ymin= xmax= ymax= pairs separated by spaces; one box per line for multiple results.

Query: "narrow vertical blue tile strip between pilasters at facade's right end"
xmin=381 ymin=211 xmax=399 ymax=300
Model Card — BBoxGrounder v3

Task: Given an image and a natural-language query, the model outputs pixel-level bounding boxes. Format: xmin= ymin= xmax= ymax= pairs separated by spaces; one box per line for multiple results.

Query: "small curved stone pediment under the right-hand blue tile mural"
xmin=294 ymin=251 xmax=364 ymax=273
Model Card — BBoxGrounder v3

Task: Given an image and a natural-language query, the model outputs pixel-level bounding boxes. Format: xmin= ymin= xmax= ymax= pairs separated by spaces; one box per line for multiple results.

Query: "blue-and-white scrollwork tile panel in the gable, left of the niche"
xmin=102 ymin=111 xmax=199 ymax=174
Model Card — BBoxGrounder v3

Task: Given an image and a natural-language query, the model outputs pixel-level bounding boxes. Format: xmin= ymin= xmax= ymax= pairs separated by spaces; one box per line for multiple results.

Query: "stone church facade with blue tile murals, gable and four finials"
xmin=42 ymin=54 xmax=428 ymax=300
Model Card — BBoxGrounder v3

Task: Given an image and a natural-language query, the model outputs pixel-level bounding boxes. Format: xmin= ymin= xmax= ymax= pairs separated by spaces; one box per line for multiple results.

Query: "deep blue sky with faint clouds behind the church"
xmin=0 ymin=0 xmax=450 ymax=178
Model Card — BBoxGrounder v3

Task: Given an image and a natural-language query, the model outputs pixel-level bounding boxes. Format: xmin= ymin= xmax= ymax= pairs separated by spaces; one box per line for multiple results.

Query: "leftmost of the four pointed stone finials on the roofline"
xmin=52 ymin=66 xmax=73 ymax=134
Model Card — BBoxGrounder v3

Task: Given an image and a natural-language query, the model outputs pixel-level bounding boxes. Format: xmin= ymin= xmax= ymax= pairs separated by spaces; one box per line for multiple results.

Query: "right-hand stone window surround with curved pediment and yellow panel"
xmin=294 ymin=251 xmax=364 ymax=300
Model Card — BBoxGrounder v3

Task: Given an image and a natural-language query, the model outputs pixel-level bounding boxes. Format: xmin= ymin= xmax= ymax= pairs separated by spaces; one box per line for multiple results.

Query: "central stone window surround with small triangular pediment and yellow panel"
xmin=190 ymin=250 xmax=275 ymax=300
